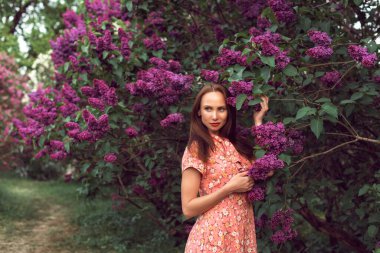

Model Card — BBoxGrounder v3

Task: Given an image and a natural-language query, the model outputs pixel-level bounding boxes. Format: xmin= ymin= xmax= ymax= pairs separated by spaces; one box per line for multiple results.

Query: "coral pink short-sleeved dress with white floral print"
xmin=182 ymin=135 xmax=257 ymax=253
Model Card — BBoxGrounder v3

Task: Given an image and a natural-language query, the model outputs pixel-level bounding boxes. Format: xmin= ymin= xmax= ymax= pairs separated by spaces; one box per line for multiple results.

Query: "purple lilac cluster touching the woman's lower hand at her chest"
xmin=248 ymin=154 xmax=285 ymax=180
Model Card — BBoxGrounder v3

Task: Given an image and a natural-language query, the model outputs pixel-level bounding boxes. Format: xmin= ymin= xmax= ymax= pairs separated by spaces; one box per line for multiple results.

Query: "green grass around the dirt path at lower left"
xmin=0 ymin=173 xmax=183 ymax=253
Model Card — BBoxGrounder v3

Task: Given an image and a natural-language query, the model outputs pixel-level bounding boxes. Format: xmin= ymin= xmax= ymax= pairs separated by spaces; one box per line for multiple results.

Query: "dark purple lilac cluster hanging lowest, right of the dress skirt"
xmin=270 ymin=209 xmax=297 ymax=244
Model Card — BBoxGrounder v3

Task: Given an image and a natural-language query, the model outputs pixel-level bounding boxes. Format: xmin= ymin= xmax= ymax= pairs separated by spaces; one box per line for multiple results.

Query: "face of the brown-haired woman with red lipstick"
xmin=198 ymin=91 xmax=228 ymax=134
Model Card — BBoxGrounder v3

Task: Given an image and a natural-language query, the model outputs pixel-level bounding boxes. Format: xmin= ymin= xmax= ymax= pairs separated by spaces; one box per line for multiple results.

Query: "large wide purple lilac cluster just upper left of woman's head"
xmin=125 ymin=57 xmax=193 ymax=105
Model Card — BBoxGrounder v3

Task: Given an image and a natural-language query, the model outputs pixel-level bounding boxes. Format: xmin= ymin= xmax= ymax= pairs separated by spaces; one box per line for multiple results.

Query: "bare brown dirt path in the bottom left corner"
xmin=0 ymin=204 xmax=84 ymax=253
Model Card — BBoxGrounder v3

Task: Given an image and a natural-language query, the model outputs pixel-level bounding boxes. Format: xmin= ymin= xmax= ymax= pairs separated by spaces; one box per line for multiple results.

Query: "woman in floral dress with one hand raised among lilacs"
xmin=181 ymin=84 xmax=269 ymax=253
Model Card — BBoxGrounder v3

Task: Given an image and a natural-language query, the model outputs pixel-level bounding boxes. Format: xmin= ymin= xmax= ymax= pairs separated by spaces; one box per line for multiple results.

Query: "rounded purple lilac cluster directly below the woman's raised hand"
xmin=252 ymin=122 xmax=288 ymax=155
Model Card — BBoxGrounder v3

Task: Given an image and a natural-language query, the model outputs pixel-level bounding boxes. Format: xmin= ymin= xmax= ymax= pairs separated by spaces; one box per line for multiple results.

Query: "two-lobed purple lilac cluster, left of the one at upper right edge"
xmin=306 ymin=30 xmax=333 ymax=59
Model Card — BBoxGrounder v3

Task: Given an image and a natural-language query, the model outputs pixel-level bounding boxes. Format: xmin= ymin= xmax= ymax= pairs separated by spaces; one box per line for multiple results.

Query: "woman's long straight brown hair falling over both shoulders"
xmin=187 ymin=83 xmax=253 ymax=162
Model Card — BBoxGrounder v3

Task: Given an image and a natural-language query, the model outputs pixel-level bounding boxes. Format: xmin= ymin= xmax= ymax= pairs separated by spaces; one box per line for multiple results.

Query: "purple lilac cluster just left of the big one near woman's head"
xmin=80 ymin=79 xmax=118 ymax=111
